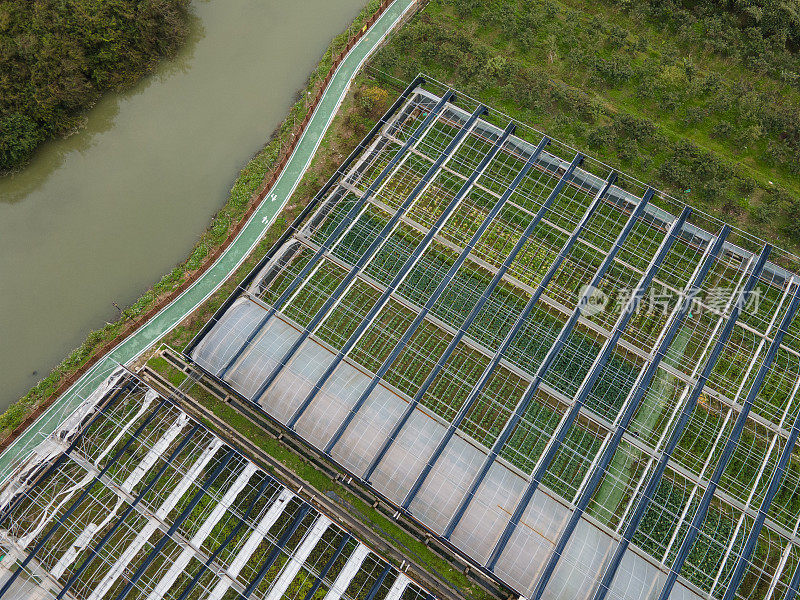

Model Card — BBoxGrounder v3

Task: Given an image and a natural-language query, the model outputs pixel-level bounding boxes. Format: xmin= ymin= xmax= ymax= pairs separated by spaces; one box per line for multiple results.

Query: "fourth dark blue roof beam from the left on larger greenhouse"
xmin=324 ymin=137 xmax=550 ymax=454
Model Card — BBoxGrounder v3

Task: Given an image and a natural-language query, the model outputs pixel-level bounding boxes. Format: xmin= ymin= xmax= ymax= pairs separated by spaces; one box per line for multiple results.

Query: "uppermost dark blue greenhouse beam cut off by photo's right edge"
xmin=659 ymin=284 xmax=800 ymax=600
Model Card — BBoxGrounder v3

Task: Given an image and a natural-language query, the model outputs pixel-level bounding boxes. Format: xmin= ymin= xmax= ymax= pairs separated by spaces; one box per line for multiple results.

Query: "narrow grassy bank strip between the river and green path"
xmin=0 ymin=1 xmax=396 ymax=438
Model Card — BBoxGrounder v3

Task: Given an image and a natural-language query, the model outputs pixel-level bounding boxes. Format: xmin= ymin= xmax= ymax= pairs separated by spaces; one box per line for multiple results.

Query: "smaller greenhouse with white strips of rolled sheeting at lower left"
xmin=0 ymin=369 xmax=433 ymax=600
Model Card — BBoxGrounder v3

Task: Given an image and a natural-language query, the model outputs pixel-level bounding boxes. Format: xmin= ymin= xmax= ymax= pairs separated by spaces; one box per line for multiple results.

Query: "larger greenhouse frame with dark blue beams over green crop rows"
xmin=186 ymin=78 xmax=800 ymax=600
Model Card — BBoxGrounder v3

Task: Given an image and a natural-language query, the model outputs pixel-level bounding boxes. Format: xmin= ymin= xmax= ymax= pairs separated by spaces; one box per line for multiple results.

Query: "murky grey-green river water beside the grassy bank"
xmin=0 ymin=0 xmax=365 ymax=409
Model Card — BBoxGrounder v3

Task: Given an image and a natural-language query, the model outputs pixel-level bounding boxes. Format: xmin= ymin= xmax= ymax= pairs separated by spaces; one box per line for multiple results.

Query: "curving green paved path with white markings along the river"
xmin=0 ymin=0 xmax=415 ymax=481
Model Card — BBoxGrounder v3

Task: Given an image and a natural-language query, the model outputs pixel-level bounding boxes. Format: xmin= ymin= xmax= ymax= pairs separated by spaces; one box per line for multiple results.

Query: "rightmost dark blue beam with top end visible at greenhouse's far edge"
xmin=593 ymin=244 xmax=772 ymax=600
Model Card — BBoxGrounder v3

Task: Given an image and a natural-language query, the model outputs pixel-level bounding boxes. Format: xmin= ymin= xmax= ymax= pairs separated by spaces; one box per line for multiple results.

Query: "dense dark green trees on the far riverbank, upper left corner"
xmin=0 ymin=0 xmax=189 ymax=171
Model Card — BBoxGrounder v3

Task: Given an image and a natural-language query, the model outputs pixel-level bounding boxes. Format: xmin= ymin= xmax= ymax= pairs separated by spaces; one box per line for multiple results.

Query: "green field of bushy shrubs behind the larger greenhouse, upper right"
xmin=375 ymin=0 xmax=800 ymax=250
